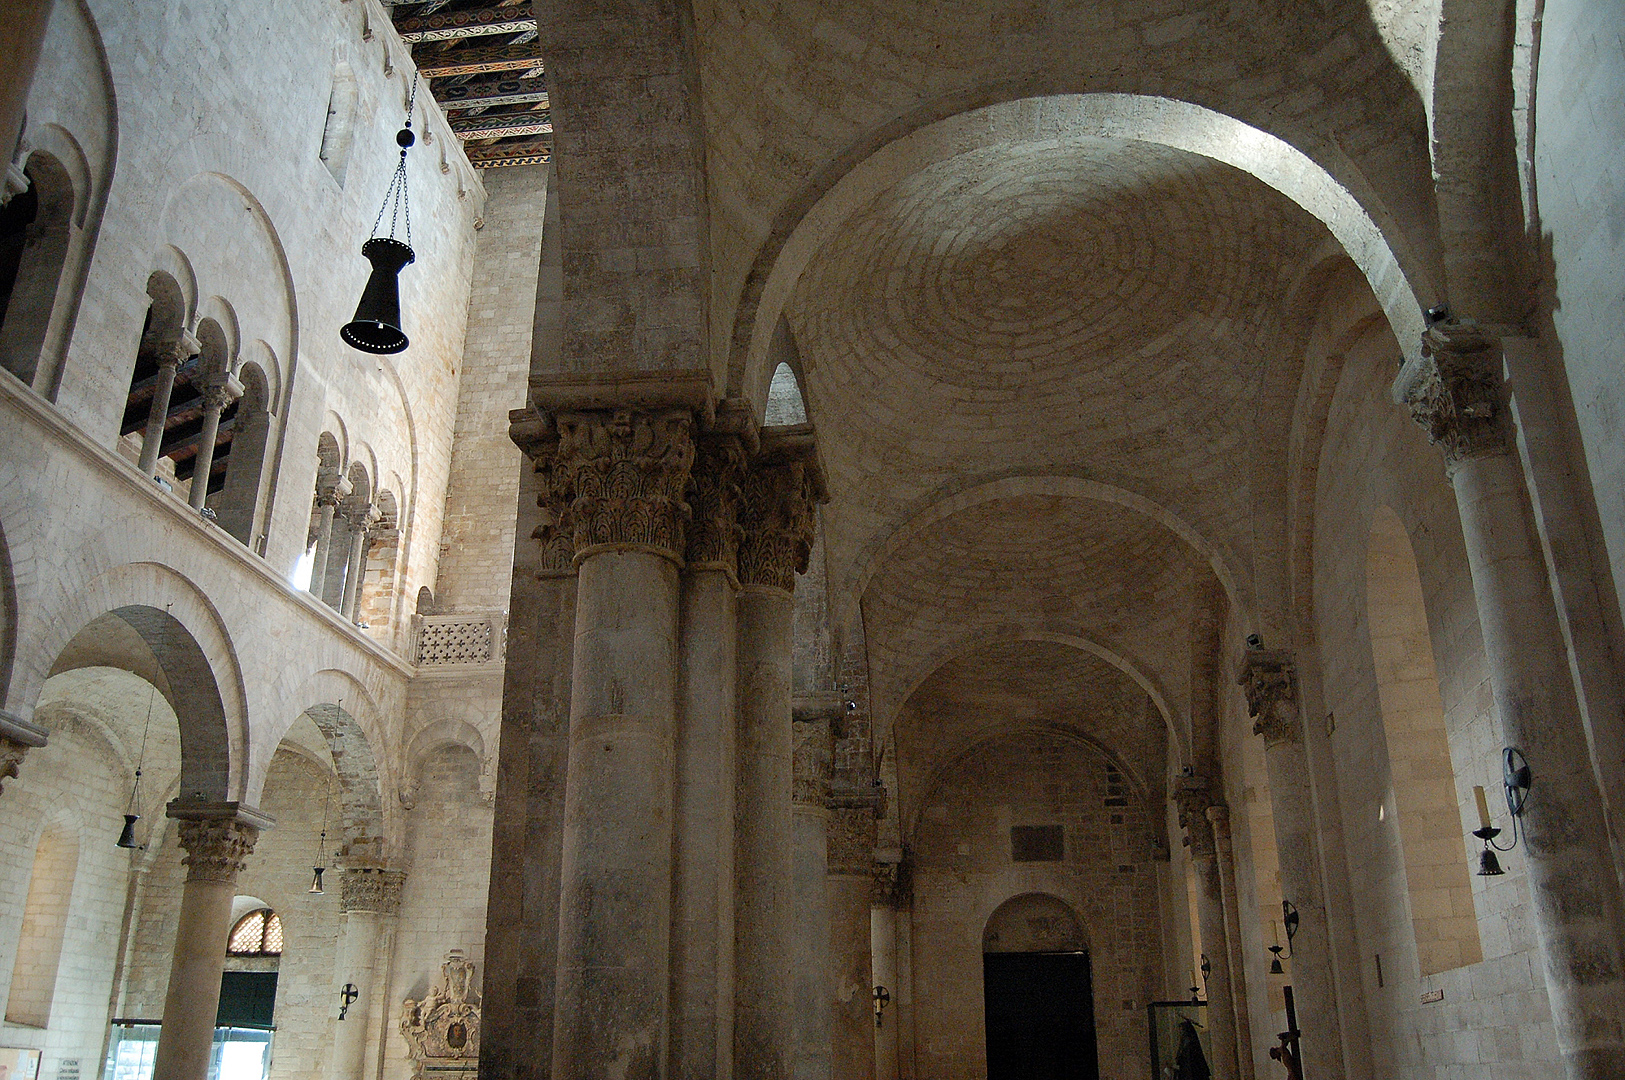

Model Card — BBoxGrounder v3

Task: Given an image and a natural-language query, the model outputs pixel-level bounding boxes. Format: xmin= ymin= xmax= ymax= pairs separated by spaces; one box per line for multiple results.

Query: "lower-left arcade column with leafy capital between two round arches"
xmin=153 ymin=799 xmax=271 ymax=1080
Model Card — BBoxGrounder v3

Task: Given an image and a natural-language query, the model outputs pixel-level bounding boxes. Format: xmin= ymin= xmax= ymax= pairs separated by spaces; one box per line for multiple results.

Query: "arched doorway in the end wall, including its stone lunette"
xmin=982 ymin=893 xmax=1100 ymax=1080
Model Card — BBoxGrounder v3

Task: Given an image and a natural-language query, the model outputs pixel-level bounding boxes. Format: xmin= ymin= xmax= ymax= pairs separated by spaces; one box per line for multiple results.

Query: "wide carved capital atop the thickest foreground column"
xmin=553 ymin=409 xmax=694 ymax=564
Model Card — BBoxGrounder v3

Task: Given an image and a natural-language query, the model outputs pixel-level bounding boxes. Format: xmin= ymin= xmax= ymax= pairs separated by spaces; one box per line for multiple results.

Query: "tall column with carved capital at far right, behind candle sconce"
xmin=1394 ymin=320 xmax=1625 ymax=1080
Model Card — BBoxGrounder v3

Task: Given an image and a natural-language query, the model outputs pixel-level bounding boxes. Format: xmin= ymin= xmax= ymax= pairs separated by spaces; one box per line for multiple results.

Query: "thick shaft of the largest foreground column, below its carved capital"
xmin=553 ymin=551 xmax=678 ymax=1080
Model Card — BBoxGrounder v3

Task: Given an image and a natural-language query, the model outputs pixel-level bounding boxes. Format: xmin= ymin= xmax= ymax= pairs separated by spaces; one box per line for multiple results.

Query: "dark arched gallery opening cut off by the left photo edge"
xmin=0 ymin=151 xmax=73 ymax=385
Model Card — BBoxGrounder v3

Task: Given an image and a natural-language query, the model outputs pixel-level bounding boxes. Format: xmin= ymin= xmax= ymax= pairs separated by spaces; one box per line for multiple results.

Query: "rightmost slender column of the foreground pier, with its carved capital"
xmin=733 ymin=440 xmax=822 ymax=1080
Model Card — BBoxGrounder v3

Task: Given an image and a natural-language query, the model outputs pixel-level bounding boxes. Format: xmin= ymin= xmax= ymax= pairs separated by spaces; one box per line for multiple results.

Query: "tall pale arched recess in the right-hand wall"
xmin=1365 ymin=507 xmax=1484 ymax=974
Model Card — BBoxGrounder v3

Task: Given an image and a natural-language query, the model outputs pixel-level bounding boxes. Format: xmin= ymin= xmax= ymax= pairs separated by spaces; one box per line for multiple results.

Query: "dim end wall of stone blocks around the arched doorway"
xmin=910 ymin=732 xmax=1164 ymax=1080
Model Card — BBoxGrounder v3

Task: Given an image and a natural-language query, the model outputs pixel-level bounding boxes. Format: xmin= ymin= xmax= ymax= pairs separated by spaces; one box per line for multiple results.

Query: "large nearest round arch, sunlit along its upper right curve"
xmin=726 ymin=94 xmax=1437 ymax=416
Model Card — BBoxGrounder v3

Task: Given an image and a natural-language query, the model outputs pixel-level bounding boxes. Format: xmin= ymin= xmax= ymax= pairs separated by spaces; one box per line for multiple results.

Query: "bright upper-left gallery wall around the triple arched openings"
xmin=15 ymin=0 xmax=483 ymax=648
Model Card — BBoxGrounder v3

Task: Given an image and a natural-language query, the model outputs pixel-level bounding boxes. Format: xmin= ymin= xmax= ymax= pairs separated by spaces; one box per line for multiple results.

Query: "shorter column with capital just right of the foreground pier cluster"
xmin=829 ymin=783 xmax=895 ymax=1080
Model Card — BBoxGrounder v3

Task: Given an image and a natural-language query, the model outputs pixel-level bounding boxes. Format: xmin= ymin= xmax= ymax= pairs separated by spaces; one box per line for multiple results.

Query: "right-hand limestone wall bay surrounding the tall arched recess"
xmin=1305 ymin=290 xmax=1560 ymax=1080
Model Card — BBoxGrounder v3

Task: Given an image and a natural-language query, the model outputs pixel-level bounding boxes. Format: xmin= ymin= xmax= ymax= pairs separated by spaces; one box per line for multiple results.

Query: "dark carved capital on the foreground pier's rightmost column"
xmin=739 ymin=443 xmax=826 ymax=593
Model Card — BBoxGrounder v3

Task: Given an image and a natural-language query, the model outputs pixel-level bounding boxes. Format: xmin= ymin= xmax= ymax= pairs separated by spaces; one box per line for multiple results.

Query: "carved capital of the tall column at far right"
xmin=1402 ymin=320 xmax=1511 ymax=469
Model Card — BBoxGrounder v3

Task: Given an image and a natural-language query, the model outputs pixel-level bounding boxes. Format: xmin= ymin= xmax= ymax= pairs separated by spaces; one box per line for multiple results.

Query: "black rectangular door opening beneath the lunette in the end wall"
xmin=982 ymin=952 xmax=1100 ymax=1080
